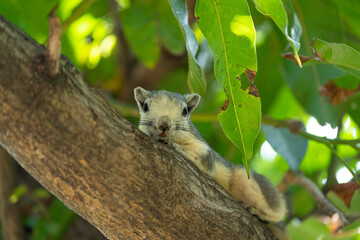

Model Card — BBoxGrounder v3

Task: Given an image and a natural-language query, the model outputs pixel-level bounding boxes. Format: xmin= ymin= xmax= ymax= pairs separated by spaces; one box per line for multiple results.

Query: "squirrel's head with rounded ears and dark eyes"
xmin=134 ymin=87 xmax=200 ymax=142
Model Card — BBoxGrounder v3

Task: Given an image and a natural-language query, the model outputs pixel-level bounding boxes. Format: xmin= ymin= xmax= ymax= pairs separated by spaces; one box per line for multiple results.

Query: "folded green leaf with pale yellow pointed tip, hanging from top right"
xmin=253 ymin=0 xmax=302 ymax=66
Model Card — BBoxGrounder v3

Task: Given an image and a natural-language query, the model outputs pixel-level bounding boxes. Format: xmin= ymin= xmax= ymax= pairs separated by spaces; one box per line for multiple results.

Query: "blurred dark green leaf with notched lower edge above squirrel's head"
xmin=121 ymin=0 xmax=184 ymax=68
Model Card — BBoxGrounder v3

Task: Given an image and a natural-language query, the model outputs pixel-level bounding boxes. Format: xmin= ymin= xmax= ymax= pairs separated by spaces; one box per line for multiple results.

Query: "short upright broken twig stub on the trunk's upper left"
xmin=46 ymin=5 xmax=61 ymax=77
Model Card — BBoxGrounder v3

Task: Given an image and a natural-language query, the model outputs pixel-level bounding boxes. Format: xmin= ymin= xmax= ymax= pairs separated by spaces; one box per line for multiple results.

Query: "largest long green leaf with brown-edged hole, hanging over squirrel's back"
xmin=195 ymin=0 xmax=261 ymax=169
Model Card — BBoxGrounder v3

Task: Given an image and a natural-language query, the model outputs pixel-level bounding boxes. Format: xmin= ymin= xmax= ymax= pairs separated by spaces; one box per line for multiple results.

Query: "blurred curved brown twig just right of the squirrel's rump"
xmin=279 ymin=171 xmax=348 ymax=227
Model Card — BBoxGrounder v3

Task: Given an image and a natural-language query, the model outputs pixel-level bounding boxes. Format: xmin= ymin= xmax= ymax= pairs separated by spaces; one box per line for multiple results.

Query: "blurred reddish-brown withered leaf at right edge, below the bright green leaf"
xmin=319 ymin=80 xmax=360 ymax=106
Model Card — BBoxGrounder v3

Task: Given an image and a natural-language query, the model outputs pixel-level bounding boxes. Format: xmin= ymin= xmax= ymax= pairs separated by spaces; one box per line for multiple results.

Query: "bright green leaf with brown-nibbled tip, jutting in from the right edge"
xmin=312 ymin=39 xmax=360 ymax=79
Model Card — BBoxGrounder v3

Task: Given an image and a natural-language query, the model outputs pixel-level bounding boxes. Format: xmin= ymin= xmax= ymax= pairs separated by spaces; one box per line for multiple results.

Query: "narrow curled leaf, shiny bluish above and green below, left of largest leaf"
xmin=169 ymin=0 xmax=206 ymax=95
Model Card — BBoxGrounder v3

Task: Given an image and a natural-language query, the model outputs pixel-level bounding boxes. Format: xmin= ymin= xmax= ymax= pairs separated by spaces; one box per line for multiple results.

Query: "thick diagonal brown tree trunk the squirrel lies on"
xmin=0 ymin=16 xmax=274 ymax=239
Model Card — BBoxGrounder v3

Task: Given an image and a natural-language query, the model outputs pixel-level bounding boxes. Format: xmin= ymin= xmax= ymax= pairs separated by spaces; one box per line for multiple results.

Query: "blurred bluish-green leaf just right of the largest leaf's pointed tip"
xmin=261 ymin=125 xmax=308 ymax=171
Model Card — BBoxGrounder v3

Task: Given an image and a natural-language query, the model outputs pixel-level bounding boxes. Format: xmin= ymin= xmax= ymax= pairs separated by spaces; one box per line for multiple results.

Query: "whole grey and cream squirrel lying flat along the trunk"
xmin=134 ymin=87 xmax=286 ymax=223
